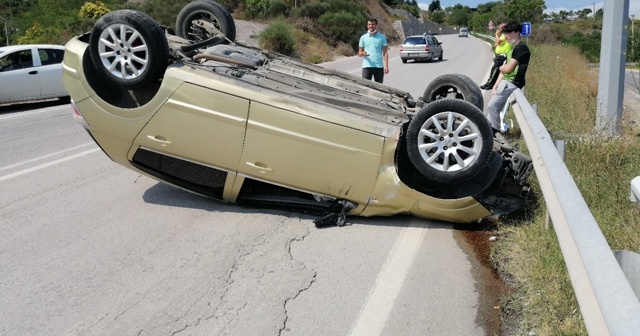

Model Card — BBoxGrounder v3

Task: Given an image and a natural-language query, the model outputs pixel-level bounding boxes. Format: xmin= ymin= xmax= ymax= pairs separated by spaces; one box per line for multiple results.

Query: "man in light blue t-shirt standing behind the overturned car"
xmin=358 ymin=19 xmax=389 ymax=83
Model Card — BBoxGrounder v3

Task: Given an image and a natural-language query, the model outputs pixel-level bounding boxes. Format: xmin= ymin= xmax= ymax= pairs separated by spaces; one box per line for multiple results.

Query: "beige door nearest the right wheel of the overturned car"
xmin=238 ymin=102 xmax=384 ymax=204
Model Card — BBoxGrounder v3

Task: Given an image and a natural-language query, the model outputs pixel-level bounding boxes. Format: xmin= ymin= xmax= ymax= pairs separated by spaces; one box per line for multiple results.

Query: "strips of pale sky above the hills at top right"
xmin=418 ymin=0 xmax=640 ymax=19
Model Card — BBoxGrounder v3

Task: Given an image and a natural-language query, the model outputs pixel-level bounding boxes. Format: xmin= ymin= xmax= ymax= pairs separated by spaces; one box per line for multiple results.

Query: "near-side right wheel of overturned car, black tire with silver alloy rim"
xmin=406 ymin=99 xmax=493 ymax=184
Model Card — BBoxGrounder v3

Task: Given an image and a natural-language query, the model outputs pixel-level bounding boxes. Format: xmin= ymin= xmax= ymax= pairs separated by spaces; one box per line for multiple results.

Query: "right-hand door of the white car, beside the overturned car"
xmin=32 ymin=48 xmax=69 ymax=98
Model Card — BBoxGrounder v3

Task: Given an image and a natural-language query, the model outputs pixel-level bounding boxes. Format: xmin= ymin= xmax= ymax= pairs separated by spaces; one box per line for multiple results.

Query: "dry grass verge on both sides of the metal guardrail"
xmin=492 ymin=45 xmax=640 ymax=335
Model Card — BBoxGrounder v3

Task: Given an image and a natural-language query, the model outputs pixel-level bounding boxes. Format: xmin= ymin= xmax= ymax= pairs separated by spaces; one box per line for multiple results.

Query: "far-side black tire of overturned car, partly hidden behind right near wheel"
xmin=422 ymin=74 xmax=484 ymax=111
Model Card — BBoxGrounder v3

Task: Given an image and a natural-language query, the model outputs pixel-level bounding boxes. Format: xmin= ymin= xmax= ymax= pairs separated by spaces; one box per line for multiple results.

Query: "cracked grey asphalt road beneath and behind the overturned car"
xmin=0 ymin=35 xmax=498 ymax=336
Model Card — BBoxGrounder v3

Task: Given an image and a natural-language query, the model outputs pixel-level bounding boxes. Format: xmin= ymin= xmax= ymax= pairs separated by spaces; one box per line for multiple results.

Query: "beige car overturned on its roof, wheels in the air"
xmin=63 ymin=0 xmax=531 ymax=225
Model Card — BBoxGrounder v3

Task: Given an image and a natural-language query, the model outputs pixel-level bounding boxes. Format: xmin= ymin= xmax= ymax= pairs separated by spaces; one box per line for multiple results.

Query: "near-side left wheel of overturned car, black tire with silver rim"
xmin=89 ymin=9 xmax=169 ymax=90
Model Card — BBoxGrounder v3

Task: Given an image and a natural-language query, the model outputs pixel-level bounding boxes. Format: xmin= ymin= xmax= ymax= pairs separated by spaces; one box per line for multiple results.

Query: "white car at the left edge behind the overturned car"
xmin=0 ymin=44 xmax=69 ymax=104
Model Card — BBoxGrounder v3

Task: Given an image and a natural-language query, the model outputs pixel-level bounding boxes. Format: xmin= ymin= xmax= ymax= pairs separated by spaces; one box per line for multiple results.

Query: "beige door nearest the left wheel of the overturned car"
xmin=132 ymin=83 xmax=249 ymax=173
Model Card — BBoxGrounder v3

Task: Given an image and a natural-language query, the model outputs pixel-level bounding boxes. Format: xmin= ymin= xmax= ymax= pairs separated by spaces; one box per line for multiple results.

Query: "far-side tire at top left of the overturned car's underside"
xmin=176 ymin=0 xmax=236 ymax=43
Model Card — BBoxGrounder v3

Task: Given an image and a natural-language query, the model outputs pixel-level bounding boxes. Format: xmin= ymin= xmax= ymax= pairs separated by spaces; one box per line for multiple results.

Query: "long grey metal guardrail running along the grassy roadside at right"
xmin=513 ymin=89 xmax=640 ymax=336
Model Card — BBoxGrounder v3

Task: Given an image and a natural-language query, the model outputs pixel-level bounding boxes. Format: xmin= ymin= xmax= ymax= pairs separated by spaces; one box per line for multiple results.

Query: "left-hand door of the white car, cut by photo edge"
xmin=0 ymin=49 xmax=40 ymax=103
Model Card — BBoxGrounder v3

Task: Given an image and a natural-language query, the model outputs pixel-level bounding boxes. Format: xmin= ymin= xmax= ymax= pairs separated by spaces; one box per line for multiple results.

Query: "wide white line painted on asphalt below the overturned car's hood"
xmin=349 ymin=223 xmax=425 ymax=336
